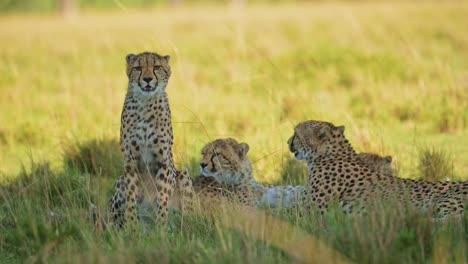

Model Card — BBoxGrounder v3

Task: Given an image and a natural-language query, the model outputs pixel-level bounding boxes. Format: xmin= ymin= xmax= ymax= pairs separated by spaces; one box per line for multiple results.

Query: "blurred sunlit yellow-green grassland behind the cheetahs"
xmin=0 ymin=0 xmax=468 ymax=186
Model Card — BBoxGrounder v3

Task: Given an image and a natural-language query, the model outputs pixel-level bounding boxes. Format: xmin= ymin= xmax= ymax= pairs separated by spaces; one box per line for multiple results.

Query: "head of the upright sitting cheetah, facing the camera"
xmin=126 ymin=52 xmax=171 ymax=96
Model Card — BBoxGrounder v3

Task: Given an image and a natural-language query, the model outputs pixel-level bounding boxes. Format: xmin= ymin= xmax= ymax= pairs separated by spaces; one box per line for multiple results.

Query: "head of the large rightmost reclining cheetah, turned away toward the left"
xmin=288 ymin=120 xmax=346 ymax=161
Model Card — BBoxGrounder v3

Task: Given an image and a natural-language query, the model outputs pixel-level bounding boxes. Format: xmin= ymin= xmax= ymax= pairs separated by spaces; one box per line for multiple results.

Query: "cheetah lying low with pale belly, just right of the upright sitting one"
xmin=193 ymin=138 xmax=305 ymax=207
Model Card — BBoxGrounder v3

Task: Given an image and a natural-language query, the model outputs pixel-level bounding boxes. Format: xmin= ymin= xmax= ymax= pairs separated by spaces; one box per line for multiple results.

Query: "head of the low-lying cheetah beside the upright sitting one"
xmin=200 ymin=138 xmax=252 ymax=185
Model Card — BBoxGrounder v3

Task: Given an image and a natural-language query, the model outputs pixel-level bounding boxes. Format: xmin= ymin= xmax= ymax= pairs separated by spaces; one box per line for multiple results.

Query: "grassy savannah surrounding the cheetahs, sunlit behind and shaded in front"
xmin=0 ymin=1 xmax=468 ymax=263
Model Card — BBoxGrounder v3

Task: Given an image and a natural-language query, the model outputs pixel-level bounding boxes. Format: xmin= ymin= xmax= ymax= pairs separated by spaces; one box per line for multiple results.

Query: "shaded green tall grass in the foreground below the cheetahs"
xmin=0 ymin=158 xmax=468 ymax=263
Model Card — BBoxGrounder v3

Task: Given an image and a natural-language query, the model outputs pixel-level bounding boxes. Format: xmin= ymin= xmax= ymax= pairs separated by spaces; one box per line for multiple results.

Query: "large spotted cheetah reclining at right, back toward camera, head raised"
xmin=288 ymin=121 xmax=468 ymax=218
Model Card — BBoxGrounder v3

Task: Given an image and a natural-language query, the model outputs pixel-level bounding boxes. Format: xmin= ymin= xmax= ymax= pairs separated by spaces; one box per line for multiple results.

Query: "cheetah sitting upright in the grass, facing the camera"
xmin=111 ymin=52 xmax=193 ymax=227
